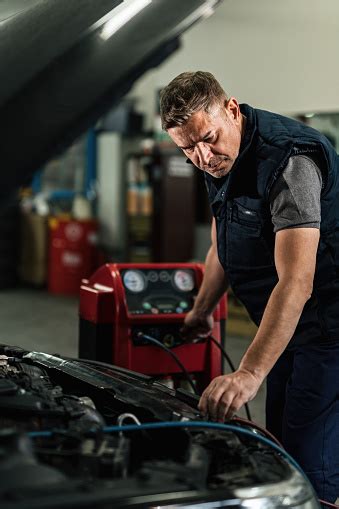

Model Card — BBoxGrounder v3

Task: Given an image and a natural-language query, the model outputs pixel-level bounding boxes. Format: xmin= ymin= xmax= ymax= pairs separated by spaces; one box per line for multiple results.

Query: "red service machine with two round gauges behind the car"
xmin=79 ymin=263 xmax=226 ymax=391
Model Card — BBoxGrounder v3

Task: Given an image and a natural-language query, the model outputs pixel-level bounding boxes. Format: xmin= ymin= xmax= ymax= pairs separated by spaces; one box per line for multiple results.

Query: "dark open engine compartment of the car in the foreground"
xmin=0 ymin=347 xmax=306 ymax=508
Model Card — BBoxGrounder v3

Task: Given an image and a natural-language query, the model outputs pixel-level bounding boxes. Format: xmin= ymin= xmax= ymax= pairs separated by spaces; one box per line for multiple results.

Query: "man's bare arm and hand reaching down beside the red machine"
xmin=181 ymin=218 xmax=228 ymax=339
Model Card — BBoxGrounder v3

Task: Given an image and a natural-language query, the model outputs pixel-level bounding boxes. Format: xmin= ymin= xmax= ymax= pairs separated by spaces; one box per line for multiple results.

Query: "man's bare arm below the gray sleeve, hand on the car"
xmin=199 ymin=228 xmax=319 ymax=421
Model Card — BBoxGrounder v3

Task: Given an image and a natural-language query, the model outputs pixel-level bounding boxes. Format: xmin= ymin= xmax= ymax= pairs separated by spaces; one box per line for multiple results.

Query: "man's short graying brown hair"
xmin=160 ymin=71 xmax=227 ymax=130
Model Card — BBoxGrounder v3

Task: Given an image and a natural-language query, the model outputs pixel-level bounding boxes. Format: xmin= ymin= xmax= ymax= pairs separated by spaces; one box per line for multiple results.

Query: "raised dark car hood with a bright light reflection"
xmin=0 ymin=0 xmax=219 ymax=199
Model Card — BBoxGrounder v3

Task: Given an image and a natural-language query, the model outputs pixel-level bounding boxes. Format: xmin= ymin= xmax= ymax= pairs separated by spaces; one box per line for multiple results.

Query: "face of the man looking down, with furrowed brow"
xmin=168 ymin=97 xmax=243 ymax=178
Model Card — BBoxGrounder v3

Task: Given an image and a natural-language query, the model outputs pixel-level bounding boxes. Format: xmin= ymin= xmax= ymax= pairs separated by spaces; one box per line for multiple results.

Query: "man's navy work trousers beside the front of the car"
xmin=266 ymin=343 xmax=339 ymax=502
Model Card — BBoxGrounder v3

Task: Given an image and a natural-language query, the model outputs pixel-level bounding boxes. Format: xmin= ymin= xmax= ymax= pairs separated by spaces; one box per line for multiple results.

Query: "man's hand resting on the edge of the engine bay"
xmin=199 ymin=369 xmax=263 ymax=422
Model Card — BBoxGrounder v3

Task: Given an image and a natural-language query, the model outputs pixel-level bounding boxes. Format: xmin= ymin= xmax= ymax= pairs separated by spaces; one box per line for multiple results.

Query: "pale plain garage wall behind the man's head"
xmin=131 ymin=0 xmax=339 ymax=127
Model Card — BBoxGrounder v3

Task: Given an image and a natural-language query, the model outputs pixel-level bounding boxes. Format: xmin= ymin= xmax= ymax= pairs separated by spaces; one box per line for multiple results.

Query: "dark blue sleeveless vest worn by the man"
xmin=206 ymin=105 xmax=339 ymax=345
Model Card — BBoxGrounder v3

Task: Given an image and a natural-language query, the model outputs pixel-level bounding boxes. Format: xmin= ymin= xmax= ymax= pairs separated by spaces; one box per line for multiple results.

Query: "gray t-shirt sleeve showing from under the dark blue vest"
xmin=269 ymin=155 xmax=322 ymax=232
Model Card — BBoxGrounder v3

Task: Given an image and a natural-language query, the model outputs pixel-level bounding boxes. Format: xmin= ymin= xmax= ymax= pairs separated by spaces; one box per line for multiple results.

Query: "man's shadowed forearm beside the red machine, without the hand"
xmin=194 ymin=245 xmax=228 ymax=315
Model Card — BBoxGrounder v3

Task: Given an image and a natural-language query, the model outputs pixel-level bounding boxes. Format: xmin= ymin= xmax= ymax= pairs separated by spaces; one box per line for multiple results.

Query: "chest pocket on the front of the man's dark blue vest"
xmin=226 ymin=202 xmax=274 ymax=273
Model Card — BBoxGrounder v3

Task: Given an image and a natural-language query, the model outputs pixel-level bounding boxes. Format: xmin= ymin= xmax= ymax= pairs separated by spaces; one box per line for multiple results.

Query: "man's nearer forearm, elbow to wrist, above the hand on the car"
xmin=239 ymin=282 xmax=310 ymax=380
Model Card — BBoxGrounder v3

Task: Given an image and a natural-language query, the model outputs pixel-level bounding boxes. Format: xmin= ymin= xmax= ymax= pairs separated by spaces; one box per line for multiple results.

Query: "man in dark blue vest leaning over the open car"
xmin=161 ymin=72 xmax=339 ymax=501
